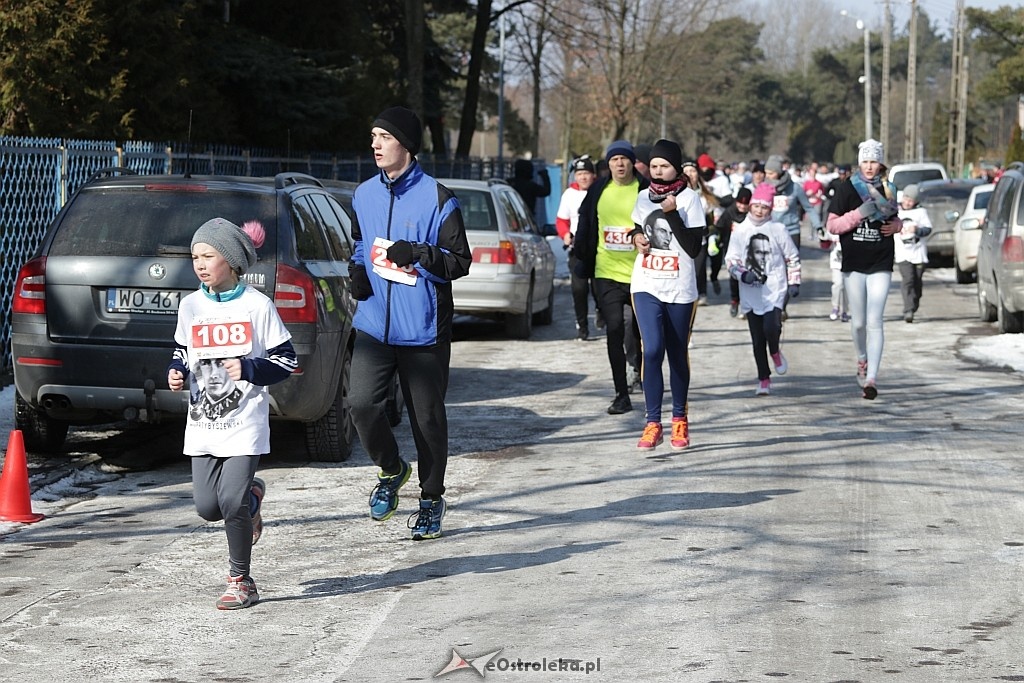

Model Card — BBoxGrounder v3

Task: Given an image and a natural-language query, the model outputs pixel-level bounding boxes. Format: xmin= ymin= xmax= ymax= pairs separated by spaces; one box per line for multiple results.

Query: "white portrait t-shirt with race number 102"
xmin=630 ymin=187 xmax=707 ymax=303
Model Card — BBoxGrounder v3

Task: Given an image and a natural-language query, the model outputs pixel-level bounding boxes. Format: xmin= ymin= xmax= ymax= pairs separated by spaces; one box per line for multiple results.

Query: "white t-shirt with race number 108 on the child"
xmin=174 ymin=287 xmax=291 ymax=458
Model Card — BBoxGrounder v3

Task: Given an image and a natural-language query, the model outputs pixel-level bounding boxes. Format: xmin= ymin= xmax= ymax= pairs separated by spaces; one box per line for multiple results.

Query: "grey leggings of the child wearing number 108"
xmin=191 ymin=456 xmax=259 ymax=577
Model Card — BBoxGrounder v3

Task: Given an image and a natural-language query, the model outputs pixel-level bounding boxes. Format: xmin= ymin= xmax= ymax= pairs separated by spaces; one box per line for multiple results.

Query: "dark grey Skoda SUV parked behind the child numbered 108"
xmin=11 ymin=169 xmax=401 ymax=462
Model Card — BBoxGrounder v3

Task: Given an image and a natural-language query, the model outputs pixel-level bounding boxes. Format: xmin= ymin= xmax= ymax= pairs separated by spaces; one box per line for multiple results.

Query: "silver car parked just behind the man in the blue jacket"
xmin=437 ymin=178 xmax=555 ymax=339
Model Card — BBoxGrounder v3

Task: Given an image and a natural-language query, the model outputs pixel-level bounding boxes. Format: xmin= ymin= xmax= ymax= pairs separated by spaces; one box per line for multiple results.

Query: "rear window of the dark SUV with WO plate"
xmin=49 ymin=187 xmax=278 ymax=257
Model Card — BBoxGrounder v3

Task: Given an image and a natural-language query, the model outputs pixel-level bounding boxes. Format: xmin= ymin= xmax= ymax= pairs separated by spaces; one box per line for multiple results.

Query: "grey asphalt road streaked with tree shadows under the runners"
xmin=0 ymin=244 xmax=1024 ymax=683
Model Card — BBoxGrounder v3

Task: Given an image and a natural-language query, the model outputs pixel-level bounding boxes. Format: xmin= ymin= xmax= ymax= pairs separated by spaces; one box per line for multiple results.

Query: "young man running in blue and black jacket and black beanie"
xmin=348 ymin=106 xmax=472 ymax=541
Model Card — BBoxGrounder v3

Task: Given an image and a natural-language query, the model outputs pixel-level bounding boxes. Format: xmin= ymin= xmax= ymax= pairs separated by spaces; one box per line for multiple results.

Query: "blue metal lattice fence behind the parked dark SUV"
xmin=0 ymin=136 xmax=511 ymax=384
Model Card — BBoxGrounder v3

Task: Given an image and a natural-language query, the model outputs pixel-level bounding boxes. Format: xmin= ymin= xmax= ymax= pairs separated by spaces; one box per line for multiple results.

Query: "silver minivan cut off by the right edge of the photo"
xmin=978 ymin=162 xmax=1024 ymax=333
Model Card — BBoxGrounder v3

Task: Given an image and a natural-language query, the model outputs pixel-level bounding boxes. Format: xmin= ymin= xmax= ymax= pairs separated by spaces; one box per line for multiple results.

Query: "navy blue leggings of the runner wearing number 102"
xmin=633 ymin=292 xmax=696 ymax=423
